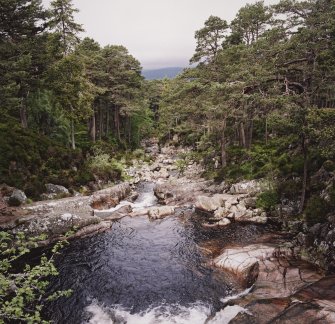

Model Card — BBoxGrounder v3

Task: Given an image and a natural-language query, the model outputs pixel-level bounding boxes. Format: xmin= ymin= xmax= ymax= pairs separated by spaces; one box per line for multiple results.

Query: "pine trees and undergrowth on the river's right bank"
xmin=156 ymin=1 xmax=335 ymax=223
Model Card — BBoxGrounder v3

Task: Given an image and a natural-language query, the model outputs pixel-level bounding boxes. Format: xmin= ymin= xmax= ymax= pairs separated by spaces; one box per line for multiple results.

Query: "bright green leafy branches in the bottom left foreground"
xmin=0 ymin=232 xmax=71 ymax=323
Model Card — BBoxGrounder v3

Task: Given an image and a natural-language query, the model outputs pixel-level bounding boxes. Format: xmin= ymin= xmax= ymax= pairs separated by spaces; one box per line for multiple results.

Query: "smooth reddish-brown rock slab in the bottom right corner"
xmin=215 ymin=243 xmax=335 ymax=324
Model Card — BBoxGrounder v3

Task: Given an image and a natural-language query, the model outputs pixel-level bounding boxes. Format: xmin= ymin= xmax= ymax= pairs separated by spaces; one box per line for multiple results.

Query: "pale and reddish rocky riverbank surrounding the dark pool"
xmin=1 ymin=140 xmax=335 ymax=323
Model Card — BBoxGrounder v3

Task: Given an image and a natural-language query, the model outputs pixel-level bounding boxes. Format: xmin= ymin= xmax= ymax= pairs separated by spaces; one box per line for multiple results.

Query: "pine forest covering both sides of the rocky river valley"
xmin=0 ymin=0 xmax=335 ymax=323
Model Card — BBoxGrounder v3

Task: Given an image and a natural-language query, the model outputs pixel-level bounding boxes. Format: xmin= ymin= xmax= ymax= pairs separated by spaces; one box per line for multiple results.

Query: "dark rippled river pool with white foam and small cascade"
xmin=47 ymin=183 xmax=265 ymax=324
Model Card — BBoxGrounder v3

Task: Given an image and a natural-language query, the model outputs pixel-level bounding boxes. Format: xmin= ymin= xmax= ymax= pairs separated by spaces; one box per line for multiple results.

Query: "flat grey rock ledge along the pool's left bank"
xmin=1 ymin=184 xmax=134 ymax=241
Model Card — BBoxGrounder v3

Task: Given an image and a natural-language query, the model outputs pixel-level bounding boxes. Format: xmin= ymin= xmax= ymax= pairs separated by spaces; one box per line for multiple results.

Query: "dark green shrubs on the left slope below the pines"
xmin=0 ymin=120 xmax=84 ymax=198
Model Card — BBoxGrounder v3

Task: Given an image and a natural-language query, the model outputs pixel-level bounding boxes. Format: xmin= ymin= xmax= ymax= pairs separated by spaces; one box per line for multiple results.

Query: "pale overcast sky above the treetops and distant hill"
xmin=43 ymin=0 xmax=278 ymax=69
